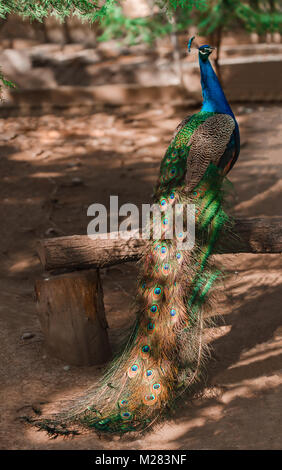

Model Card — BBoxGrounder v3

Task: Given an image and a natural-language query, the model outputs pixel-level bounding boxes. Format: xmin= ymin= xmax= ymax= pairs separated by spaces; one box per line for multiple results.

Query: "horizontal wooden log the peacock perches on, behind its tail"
xmin=37 ymin=217 xmax=282 ymax=271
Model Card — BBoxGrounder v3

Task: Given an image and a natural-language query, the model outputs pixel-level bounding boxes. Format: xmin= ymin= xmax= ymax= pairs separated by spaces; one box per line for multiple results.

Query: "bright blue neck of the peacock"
xmin=199 ymin=54 xmax=235 ymax=119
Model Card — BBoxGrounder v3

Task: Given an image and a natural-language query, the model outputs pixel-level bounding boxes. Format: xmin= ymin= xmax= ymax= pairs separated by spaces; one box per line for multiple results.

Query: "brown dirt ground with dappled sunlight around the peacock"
xmin=0 ymin=104 xmax=282 ymax=450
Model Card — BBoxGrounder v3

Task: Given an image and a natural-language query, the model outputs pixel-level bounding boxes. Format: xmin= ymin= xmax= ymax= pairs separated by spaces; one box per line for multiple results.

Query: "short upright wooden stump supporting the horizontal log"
xmin=35 ymin=270 xmax=111 ymax=366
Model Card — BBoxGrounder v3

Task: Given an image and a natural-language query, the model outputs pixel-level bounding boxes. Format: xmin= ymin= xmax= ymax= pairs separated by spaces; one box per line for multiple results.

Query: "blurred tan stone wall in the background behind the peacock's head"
xmin=0 ymin=0 xmax=282 ymax=114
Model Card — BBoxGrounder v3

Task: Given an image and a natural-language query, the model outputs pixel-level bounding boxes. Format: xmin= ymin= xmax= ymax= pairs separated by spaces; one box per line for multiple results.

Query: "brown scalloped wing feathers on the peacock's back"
xmin=186 ymin=114 xmax=235 ymax=191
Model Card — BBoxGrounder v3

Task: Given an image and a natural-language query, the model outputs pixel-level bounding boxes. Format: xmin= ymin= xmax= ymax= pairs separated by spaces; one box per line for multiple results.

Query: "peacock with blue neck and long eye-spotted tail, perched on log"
xmin=28 ymin=37 xmax=240 ymax=435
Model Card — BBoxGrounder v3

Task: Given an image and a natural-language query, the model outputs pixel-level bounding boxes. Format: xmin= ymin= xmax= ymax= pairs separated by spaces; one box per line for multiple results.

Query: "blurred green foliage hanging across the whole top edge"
xmin=0 ymin=0 xmax=282 ymax=37
